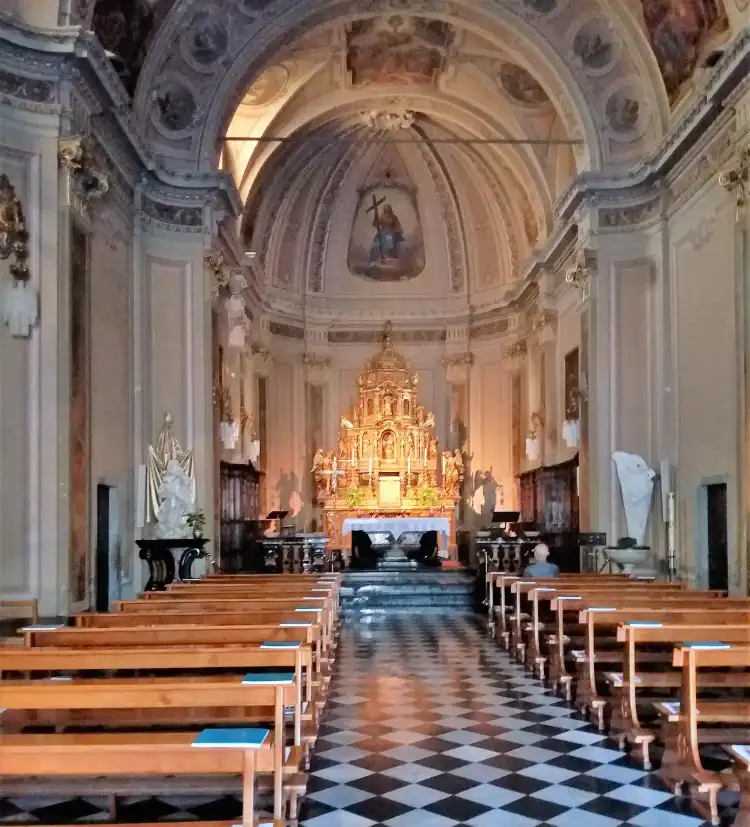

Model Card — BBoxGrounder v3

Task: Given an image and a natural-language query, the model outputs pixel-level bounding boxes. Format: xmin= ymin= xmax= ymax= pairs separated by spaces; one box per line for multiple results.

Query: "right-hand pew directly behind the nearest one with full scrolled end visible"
xmin=576 ymin=599 xmax=750 ymax=732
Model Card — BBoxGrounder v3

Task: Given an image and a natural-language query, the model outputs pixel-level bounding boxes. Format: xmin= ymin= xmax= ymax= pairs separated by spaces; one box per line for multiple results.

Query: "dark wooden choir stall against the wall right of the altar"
xmin=518 ymin=456 xmax=580 ymax=572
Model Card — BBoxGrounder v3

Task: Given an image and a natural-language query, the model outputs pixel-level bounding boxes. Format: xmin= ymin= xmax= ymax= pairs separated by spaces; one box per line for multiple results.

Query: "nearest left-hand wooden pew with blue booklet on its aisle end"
xmin=0 ymin=730 xmax=283 ymax=827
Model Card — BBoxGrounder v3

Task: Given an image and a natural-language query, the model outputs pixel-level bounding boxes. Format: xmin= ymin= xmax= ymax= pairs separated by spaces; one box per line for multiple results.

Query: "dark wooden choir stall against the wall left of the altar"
xmin=219 ymin=462 xmax=263 ymax=573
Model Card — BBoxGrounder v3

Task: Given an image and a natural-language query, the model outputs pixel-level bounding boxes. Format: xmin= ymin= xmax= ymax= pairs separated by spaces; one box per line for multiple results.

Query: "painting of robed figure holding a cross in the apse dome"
xmin=348 ymin=185 xmax=425 ymax=281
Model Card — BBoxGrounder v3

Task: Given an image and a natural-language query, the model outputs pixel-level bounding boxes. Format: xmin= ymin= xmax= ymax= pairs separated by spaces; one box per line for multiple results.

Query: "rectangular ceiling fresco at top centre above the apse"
xmin=346 ymin=15 xmax=455 ymax=86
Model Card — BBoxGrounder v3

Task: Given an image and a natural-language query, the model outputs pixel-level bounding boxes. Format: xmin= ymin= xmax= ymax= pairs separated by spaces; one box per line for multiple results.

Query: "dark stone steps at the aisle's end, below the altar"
xmin=340 ymin=569 xmax=474 ymax=613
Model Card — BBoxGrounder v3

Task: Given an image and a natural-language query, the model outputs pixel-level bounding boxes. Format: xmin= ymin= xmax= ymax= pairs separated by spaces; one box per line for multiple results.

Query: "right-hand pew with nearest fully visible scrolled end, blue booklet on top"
xmin=610 ymin=628 xmax=750 ymax=770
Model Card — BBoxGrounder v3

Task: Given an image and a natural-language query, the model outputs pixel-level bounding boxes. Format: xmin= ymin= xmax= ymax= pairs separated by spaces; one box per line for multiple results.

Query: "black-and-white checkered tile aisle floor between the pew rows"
xmin=301 ymin=615 xmax=712 ymax=827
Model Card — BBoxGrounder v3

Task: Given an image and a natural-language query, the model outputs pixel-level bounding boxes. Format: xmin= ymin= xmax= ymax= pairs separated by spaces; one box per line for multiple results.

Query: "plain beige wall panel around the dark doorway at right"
xmin=669 ymin=179 xmax=748 ymax=591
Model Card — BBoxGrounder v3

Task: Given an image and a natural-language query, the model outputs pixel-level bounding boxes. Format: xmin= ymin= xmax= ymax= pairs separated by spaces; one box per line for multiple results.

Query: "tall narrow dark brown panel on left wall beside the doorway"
xmin=69 ymin=225 xmax=90 ymax=603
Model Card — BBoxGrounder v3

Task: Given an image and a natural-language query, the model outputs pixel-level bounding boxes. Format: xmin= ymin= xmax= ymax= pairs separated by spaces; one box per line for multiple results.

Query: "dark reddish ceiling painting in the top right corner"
xmin=641 ymin=0 xmax=728 ymax=101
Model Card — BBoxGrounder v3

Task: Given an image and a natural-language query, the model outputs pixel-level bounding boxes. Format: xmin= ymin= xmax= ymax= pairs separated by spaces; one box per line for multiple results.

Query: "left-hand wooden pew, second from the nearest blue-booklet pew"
xmin=0 ymin=675 xmax=302 ymax=819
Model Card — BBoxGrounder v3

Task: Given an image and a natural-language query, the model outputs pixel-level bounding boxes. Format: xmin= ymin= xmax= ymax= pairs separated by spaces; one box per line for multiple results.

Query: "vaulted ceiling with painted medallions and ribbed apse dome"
xmin=95 ymin=0 xmax=727 ymax=316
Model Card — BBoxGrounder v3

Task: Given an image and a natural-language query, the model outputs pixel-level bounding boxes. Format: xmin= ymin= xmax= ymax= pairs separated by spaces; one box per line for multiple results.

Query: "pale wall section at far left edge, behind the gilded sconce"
xmin=0 ymin=106 xmax=69 ymax=616
